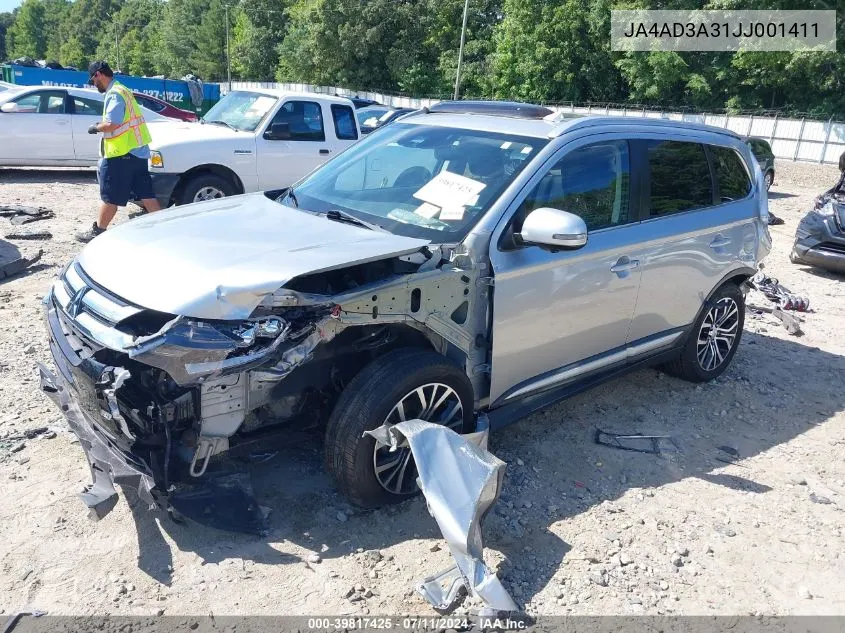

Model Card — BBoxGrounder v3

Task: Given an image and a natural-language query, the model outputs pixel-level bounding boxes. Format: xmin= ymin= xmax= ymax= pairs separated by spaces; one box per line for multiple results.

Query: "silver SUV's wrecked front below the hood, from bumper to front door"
xmin=40 ymin=242 xmax=484 ymax=532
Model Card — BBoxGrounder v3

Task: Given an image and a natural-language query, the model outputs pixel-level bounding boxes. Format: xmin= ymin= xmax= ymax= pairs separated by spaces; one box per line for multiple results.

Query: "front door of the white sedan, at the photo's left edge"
xmin=0 ymin=90 xmax=74 ymax=165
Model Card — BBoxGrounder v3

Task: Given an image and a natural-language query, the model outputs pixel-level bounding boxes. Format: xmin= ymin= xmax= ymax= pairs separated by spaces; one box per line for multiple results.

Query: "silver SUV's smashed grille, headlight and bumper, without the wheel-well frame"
xmin=40 ymin=264 xmax=338 ymax=531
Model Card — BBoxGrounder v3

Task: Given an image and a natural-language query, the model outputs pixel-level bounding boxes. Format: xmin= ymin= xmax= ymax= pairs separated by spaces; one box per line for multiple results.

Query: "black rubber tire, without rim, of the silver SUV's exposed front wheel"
xmin=324 ymin=348 xmax=475 ymax=508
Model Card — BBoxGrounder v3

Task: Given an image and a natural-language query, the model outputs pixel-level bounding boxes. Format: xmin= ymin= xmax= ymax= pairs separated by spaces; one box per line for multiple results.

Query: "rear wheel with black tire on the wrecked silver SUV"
xmin=662 ymin=282 xmax=745 ymax=382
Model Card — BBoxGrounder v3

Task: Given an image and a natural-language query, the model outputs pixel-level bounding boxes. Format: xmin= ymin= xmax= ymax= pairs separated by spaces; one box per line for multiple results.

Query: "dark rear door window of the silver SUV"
xmin=647 ymin=141 xmax=713 ymax=217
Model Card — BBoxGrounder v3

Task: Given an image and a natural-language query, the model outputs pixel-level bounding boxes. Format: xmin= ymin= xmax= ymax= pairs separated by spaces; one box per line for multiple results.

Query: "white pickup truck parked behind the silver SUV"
xmin=149 ymin=88 xmax=360 ymax=207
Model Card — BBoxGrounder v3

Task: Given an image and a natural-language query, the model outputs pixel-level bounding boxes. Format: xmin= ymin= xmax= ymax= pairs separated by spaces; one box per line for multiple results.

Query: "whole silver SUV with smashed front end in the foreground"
xmin=42 ymin=102 xmax=771 ymax=515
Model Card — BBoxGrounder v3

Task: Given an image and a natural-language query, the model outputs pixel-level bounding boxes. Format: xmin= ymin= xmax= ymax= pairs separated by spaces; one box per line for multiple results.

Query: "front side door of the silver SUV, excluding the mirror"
xmin=490 ymin=134 xmax=640 ymax=406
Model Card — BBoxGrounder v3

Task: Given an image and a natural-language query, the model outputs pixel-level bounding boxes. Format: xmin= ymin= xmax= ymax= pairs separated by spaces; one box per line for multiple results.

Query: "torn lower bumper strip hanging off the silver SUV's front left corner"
xmin=38 ymin=363 xmax=157 ymax=519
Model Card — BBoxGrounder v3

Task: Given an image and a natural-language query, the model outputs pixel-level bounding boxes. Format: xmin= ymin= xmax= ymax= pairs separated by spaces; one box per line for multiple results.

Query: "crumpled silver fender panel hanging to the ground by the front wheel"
xmin=367 ymin=418 xmax=518 ymax=613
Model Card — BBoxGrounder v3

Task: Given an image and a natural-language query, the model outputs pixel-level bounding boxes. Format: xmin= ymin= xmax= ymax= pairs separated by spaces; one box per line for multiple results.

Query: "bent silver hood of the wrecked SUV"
xmin=78 ymin=193 xmax=428 ymax=319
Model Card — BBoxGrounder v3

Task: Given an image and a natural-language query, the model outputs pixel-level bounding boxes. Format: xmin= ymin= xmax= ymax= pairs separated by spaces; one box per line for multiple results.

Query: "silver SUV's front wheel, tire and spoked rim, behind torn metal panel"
xmin=324 ymin=349 xmax=475 ymax=508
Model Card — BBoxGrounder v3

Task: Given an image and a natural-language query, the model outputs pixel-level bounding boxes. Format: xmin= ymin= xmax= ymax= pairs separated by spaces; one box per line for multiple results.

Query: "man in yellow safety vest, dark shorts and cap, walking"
xmin=76 ymin=61 xmax=161 ymax=242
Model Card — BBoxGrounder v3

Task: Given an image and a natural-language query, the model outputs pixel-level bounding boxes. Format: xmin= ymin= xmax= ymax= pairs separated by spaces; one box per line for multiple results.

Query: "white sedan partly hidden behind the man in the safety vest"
xmin=0 ymin=86 xmax=167 ymax=167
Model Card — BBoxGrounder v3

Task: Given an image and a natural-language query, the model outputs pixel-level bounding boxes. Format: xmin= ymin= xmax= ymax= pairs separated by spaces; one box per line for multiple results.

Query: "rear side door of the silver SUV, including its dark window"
xmin=629 ymin=137 xmax=755 ymax=343
